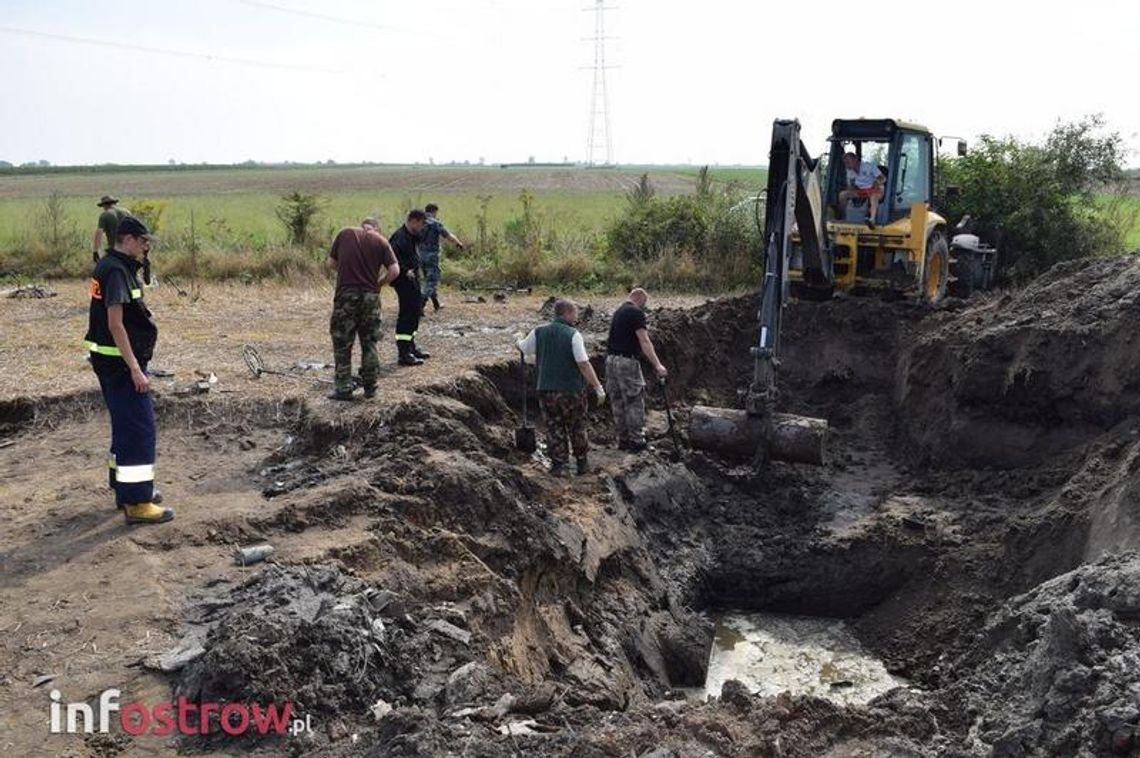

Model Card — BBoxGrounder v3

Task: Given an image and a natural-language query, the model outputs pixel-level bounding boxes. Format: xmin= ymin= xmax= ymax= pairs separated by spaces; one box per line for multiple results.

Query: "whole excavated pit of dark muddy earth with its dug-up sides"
xmin=135 ymin=258 xmax=1140 ymax=756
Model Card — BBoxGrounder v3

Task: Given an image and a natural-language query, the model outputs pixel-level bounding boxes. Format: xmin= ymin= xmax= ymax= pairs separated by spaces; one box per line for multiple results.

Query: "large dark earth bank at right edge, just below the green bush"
xmin=898 ymin=255 xmax=1140 ymax=467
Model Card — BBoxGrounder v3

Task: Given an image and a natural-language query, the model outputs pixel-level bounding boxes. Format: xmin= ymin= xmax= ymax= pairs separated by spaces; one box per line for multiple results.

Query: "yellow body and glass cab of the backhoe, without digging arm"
xmin=789 ymin=119 xmax=950 ymax=302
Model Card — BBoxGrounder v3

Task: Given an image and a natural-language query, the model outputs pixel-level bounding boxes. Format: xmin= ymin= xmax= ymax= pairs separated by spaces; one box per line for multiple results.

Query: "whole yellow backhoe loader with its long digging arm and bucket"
xmin=690 ymin=119 xmax=996 ymax=466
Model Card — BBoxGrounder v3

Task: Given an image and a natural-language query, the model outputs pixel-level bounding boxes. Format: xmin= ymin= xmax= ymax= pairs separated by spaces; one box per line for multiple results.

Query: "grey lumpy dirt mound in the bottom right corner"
xmin=938 ymin=553 xmax=1140 ymax=756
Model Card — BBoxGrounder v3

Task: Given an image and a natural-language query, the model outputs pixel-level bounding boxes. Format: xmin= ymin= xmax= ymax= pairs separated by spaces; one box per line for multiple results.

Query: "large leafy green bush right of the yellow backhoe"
xmin=939 ymin=116 xmax=1134 ymax=280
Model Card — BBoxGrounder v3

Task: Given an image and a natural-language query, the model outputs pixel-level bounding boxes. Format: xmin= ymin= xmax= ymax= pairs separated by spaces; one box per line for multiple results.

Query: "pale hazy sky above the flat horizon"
xmin=0 ymin=0 xmax=1140 ymax=165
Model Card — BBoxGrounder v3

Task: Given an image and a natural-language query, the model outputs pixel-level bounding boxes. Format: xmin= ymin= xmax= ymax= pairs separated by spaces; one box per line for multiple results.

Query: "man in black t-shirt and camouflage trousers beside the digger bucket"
xmin=605 ymin=287 xmax=668 ymax=453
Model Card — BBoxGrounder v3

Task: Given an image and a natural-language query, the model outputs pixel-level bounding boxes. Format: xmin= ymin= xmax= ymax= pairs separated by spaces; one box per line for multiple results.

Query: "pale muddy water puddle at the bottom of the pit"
xmin=692 ymin=613 xmax=907 ymax=704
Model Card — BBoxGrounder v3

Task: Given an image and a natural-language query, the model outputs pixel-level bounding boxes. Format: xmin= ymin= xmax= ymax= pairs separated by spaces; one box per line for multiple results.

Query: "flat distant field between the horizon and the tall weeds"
xmin=0 ymin=166 xmax=766 ymax=250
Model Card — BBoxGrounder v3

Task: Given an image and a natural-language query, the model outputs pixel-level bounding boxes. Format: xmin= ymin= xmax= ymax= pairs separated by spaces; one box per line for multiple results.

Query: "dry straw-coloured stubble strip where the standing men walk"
xmin=0 ymin=280 xmax=703 ymax=400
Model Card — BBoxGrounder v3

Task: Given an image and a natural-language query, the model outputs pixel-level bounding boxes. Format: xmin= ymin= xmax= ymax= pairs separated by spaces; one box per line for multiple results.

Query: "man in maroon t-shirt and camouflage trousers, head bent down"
xmin=328 ymin=218 xmax=400 ymax=400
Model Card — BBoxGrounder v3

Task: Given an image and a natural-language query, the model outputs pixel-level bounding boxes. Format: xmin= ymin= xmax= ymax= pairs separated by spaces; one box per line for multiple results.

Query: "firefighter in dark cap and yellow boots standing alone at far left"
xmin=87 ymin=217 xmax=174 ymax=524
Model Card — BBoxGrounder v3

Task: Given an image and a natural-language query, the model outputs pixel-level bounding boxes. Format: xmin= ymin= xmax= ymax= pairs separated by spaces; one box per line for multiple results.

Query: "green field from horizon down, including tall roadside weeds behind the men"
xmin=0 ymin=160 xmax=1140 ymax=291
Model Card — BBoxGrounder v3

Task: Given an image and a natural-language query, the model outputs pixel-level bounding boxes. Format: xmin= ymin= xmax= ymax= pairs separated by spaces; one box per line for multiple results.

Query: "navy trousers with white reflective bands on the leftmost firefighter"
xmin=96 ymin=366 xmax=155 ymax=505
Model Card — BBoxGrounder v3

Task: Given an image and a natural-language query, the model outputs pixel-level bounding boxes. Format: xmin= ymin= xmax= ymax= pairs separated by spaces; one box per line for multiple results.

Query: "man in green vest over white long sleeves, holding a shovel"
xmin=516 ymin=300 xmax=605 ymax=476
